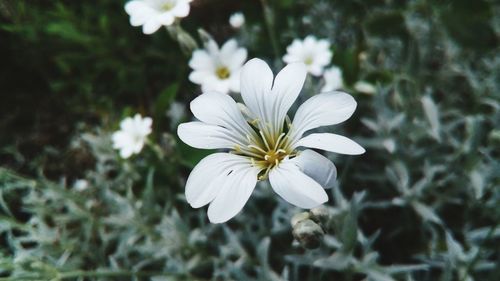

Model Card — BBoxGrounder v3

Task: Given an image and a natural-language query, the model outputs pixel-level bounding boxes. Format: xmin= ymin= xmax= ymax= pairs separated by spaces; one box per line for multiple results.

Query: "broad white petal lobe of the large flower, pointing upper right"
xmin=291 ymin=92 xmax=357 ymax=141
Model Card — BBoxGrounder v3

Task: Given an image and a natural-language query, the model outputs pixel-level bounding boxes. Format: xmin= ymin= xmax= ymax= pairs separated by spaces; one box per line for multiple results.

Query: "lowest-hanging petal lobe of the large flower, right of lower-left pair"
xmin=208 ymin=163 xmax=259 ymax=223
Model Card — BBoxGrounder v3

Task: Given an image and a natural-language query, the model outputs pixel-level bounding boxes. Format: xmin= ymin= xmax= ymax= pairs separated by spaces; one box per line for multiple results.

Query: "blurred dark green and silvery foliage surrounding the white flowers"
xmin=0 ymin=0 xmax=500 ymax=281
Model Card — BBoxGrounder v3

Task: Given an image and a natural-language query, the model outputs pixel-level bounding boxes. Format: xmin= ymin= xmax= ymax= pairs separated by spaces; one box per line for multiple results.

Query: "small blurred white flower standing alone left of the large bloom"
xmin=112 ymin=114 xmax=153 ymax=158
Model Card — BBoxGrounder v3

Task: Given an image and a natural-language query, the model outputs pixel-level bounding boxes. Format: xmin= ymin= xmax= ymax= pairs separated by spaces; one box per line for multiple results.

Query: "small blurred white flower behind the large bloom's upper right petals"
xmin=283 ymin=35 xmax=333 ymax=76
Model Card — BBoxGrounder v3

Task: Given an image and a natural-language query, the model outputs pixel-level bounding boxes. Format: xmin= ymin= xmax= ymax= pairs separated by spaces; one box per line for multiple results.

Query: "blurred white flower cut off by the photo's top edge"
xmin=125 ymin=0 xmax=191 ymax=34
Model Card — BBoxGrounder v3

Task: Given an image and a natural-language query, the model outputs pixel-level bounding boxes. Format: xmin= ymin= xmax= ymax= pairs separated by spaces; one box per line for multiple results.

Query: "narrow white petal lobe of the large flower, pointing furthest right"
xmin=295 ymin=133 xmax=365 ymax=155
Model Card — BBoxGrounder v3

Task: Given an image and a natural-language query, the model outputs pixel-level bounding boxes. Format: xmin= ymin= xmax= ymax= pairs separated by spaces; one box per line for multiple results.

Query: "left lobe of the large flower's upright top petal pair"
xmin=240 ymin=59 xmax=274 ymax=120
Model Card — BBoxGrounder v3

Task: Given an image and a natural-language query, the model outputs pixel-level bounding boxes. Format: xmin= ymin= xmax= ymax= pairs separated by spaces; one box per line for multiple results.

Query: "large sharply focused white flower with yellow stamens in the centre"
xmin=177 ymin=59 xmax=365 ymax=223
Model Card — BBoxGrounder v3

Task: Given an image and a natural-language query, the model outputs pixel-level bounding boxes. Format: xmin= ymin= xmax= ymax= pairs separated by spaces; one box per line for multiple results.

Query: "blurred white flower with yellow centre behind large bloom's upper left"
xmin=189 ymin=39 xmax=247 ymax=94
